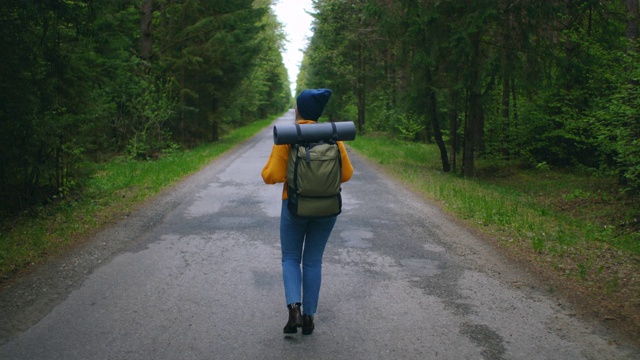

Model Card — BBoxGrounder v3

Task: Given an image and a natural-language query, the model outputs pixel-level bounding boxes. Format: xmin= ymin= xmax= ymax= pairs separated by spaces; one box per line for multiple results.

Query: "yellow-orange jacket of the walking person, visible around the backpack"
xmin=262 ymin=120 xmax=353 ymax=200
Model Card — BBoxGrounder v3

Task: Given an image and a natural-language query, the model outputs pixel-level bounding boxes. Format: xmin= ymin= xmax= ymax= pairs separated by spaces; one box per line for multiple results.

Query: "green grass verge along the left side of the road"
xmin=0 ymin=117 xmax=274 ymax=278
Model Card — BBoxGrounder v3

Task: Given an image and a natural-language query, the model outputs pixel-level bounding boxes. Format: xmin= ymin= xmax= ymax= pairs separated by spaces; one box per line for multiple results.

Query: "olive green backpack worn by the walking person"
xmin=287 ymin=128 xmax=342 ymax=218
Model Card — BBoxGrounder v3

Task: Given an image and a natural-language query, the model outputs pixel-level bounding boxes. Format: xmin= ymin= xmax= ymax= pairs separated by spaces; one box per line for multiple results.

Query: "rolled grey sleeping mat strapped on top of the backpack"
xmin=273 ymin=121 xmax=356 ymax=145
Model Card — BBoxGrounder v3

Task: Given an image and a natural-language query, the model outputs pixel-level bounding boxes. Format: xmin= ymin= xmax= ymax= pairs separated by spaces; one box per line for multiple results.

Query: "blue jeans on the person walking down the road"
xmin=280 ymin=200 xmax=337 ymax=315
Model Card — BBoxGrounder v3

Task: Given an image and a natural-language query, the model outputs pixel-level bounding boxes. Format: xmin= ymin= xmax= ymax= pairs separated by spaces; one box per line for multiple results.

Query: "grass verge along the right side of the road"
xmin=349 ymin=134 xmax=640 ymax=335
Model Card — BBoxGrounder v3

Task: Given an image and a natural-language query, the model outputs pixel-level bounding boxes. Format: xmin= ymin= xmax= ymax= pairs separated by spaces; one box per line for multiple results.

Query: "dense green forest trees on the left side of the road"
xmin=0 ymin=0 xmax=291 ymax=217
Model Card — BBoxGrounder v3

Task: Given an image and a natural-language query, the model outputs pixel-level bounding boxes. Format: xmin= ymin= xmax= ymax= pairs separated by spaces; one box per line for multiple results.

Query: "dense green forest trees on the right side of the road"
xmin=297 ymin=0 xmax=640 ymax=184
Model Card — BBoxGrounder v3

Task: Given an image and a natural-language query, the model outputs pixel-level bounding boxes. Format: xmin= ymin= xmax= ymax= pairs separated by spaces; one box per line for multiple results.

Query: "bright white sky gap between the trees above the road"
xmin=273 ymin=0 xmax=313 ymax=96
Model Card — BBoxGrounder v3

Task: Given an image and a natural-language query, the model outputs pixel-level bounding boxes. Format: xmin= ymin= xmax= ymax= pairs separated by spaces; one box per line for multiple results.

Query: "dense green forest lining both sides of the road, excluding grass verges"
xmin=0 ymin=0 xmax=640 ymax=216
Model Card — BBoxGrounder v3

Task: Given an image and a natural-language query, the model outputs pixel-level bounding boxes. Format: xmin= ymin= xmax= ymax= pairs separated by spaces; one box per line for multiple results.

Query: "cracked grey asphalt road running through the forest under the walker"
xmin=0 ymin=112 xmax=640 ymax=359
